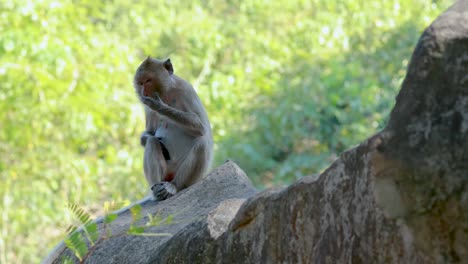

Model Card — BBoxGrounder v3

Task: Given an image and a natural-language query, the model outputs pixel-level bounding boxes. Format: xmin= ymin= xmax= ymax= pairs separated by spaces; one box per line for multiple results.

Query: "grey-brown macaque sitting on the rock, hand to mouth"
xmin=134 ymin=57 xmax=213 ymax=200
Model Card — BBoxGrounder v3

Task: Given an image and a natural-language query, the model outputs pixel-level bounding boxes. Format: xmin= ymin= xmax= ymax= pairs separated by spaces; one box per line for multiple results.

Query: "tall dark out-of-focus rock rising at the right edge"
xmin=373 ymin=1 xmax=468 ymax=263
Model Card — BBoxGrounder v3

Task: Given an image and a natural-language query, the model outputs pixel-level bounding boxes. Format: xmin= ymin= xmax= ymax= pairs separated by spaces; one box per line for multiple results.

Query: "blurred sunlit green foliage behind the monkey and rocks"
xmin=0 ymin=0 xmax=451 ymax=263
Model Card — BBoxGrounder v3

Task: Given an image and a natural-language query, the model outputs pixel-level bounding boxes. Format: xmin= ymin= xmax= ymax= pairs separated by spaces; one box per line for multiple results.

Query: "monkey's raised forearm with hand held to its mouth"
xmin=142 ymin=96 xmax=205 ymax=136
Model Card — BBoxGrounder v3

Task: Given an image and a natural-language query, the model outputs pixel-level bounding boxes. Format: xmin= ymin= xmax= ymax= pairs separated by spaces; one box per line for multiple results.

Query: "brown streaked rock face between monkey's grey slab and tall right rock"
xmin=153 ymin=143 xmax=427 ymax=263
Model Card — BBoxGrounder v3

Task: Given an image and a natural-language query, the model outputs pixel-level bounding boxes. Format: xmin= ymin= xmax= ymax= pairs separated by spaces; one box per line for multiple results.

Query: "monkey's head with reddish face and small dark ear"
xmin=133 ymin=56 xmax=174 ymax=98
